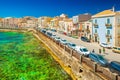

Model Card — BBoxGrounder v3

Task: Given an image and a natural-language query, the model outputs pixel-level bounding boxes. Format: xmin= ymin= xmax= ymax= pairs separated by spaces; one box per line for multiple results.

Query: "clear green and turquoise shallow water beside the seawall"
xmin=0 ymin=32 xmax=71 ymax=80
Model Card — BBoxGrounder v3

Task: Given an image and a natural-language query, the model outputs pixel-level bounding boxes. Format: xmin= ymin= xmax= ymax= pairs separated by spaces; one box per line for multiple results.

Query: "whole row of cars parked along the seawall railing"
xmin=41 ymin=29 xmax=120 ymax=75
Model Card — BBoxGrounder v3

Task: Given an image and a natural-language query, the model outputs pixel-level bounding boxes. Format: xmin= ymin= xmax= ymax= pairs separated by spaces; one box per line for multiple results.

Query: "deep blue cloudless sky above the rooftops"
xmin=0 ymin=0 xmax=120 ymax=17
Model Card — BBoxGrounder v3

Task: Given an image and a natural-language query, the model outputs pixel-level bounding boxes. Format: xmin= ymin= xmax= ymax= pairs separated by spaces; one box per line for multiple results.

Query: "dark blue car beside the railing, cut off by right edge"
xmin=109 ymin=61 xmax=120 ymax=75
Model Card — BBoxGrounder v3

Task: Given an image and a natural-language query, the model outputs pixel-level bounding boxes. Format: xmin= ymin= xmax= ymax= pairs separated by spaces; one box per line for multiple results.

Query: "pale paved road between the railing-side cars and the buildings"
xmin=52 ymin=32 xmax=120 ymax=62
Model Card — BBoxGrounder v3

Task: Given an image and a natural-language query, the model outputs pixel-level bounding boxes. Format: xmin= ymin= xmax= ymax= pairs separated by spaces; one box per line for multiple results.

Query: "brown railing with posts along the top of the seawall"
xmin=39 ymin=29 xmax=120 ymax=80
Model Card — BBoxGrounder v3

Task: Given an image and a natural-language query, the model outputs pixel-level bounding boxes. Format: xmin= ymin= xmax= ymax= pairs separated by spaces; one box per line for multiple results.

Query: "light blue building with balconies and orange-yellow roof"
xmin=92 ymin=8 xmax=120 ymax=46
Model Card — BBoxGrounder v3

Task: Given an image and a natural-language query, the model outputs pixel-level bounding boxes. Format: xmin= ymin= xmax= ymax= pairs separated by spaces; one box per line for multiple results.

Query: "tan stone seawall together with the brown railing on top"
xmin=38 ymin=32 xmax=120 ymax=80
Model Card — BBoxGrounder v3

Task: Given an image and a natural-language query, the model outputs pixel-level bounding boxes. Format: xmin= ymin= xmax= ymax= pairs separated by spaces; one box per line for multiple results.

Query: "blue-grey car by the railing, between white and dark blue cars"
xmin=89 ymin=53 xmax=108 ymax=66
